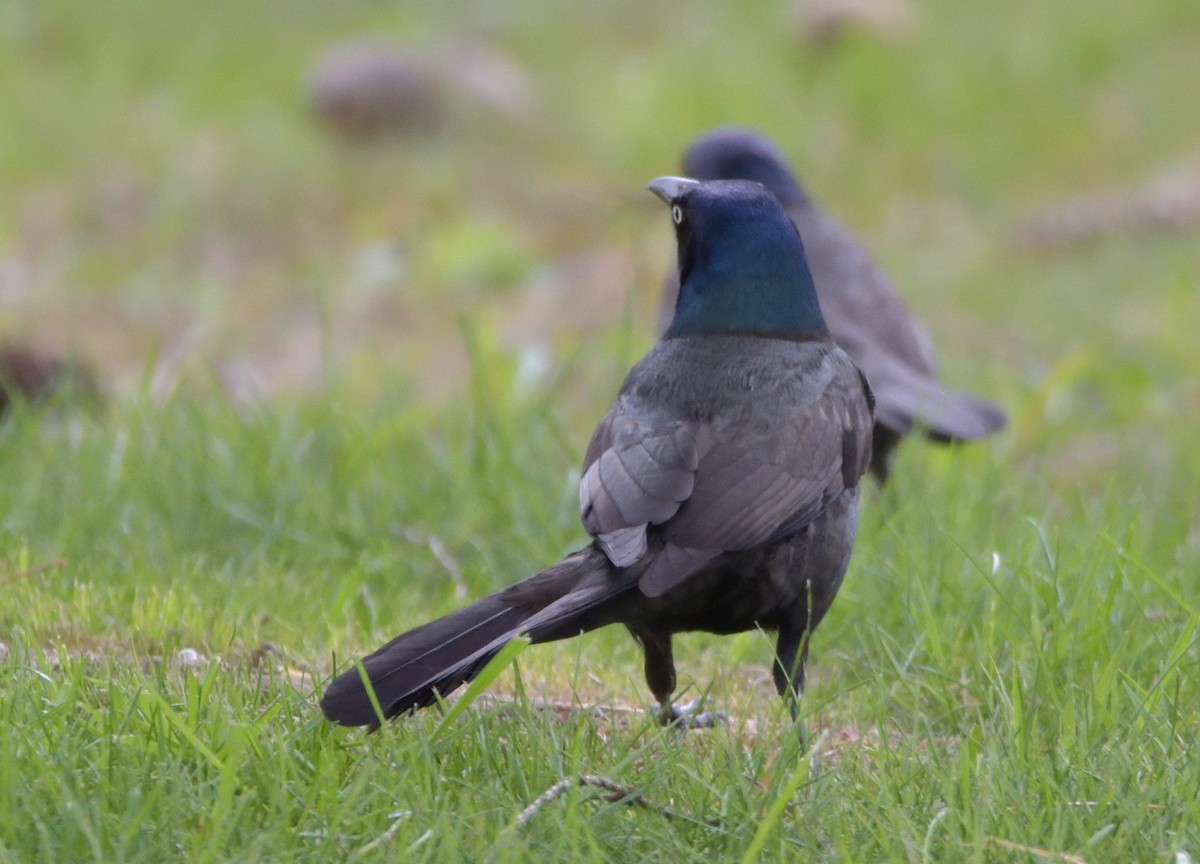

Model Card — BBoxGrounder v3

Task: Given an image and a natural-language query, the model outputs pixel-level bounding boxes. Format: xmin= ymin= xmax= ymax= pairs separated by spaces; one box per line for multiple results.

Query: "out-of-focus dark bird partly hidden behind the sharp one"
xmin=660 ymin=128 xmax=1007 ymax=482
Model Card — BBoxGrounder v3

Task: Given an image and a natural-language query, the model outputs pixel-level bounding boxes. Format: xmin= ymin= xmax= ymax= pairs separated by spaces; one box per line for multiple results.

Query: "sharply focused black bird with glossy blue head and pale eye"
xmin=320 ymin=178 xmax=872 ymax=726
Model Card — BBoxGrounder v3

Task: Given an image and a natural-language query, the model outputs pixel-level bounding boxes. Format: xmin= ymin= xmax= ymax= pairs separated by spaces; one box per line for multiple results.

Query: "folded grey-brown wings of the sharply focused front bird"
xmin=580 ymin=340 xmax=872 ymax=596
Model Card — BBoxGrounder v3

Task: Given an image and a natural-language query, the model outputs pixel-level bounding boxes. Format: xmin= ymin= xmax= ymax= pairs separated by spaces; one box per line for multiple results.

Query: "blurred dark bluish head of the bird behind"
xmin=683 ymin=126 xmax=809 ymax=208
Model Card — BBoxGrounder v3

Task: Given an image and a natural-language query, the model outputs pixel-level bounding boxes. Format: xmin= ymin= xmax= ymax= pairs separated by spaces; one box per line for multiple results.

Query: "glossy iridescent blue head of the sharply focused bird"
xmin=647 ymin=178 xmax=827 ymax=338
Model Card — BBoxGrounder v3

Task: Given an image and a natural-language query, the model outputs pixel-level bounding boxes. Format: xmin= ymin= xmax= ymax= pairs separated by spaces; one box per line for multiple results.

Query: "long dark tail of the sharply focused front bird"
xmin=320 ymin=546 xmax=637 ymax=726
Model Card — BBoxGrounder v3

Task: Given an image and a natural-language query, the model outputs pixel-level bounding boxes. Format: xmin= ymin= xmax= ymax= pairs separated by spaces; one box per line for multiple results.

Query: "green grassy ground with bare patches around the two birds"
xmin=0 ymin=0 xmax=1200 ymax=862
